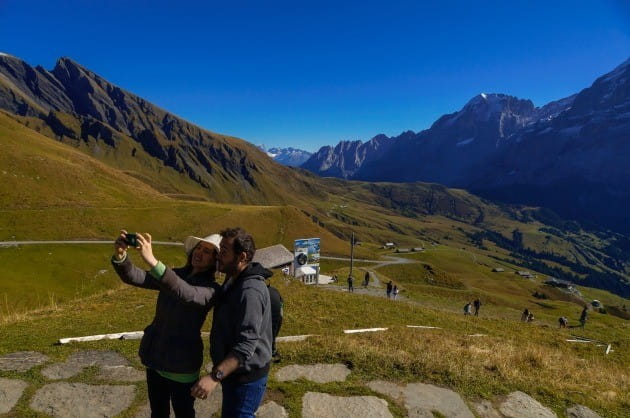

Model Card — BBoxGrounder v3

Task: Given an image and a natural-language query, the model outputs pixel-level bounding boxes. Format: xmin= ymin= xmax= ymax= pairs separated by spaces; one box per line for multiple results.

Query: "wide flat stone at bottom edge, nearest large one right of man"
xmin=302 ymin=392 xmax=393 ymax=418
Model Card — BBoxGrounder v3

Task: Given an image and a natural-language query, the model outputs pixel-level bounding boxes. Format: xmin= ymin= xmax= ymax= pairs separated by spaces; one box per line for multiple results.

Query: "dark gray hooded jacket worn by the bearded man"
xmin=210 ymin=263 xmax=273 ymax=383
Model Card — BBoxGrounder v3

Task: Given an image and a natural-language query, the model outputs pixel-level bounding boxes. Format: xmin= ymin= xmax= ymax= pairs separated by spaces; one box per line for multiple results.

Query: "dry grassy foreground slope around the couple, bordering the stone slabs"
xmin=0 ymin=279 xmax=630 ymax=417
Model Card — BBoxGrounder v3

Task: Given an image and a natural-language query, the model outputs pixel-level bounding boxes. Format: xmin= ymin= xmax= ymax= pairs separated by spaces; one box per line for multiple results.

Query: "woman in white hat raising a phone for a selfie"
xmin=112 ymin=230 xmax=221 ymax=417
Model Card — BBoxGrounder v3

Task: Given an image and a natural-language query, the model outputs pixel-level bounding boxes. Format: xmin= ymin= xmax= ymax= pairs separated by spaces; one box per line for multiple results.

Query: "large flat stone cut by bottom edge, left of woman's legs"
xmin=30 ymin=382 xmax=135 ymax=418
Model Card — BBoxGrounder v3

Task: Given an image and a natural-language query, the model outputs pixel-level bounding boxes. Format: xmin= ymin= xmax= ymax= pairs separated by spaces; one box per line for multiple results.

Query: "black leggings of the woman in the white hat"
xmin=147 ymin=369 xmax=196 ymax=418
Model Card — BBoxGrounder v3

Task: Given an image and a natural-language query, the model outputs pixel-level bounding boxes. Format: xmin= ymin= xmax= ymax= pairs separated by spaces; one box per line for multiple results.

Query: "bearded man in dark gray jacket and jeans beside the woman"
xmin=191 ymin=228 xmax=273 ymax=417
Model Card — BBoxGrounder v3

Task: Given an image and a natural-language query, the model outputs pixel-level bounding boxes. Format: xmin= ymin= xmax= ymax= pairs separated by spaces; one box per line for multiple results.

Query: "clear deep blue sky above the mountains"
xmin=0 ymin=0 xmax=630 ymax=151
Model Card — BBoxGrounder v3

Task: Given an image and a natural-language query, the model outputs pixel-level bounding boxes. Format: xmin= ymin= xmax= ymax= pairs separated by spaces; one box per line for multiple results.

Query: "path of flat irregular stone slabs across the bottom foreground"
xmin=0 ymin=350 xmax=599 ymax=418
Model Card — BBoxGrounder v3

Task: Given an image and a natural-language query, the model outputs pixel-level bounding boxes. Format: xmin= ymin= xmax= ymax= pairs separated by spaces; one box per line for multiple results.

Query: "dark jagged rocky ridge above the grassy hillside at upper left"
xmin=0 ymin=55 xmax=299 ymax=203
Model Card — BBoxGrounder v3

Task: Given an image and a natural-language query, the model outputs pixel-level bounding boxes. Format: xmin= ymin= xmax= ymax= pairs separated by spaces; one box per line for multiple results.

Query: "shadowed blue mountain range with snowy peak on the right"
xmin=302 ymin=59 xmax=630 ymax=233
